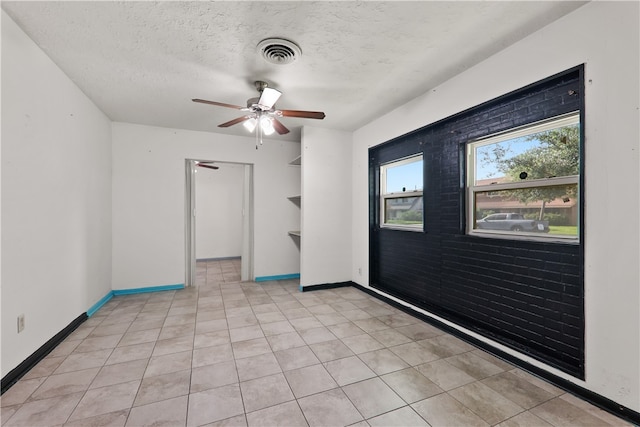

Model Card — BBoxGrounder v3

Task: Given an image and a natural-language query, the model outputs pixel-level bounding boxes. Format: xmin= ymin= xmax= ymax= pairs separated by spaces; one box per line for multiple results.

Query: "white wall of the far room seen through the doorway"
xmin=195 ymin=163 xmax=244 ymax=259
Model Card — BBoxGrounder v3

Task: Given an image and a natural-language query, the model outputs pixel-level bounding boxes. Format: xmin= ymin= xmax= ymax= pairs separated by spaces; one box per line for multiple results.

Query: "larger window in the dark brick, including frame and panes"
xmin=467 ymin=113 xmax=580 ymax=241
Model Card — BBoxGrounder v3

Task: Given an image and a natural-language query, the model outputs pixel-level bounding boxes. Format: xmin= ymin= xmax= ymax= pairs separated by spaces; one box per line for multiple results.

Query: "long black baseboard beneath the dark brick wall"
xmin=351 ymin=282 xmax=640 ymax=425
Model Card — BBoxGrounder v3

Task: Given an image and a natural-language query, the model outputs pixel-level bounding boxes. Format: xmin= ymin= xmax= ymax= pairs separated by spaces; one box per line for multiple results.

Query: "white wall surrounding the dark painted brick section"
xmin=352 ymin=2 xmax=640 ymax=411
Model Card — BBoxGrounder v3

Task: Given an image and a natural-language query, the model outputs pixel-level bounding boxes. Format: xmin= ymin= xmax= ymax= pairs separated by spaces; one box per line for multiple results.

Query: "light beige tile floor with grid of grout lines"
xmin=1 ymin=276 xmax=628 ymax=427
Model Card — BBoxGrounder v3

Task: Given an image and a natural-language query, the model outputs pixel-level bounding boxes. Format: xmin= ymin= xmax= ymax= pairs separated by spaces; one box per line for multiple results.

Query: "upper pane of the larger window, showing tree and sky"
xmin=474 ymin=123 xmax=580 ymax=185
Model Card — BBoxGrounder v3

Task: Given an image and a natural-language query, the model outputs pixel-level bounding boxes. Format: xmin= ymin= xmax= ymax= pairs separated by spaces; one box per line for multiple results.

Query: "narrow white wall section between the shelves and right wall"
xmin=300 ymin=126 xmax=351 ymax=286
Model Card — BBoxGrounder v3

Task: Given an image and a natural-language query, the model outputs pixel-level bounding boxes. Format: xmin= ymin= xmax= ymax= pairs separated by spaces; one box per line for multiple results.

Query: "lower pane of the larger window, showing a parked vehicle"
xmin=474 ymin=184 xmax=579 ymax=237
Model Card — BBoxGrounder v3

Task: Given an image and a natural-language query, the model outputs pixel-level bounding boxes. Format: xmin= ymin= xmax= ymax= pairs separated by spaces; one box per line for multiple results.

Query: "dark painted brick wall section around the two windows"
xmin=369 ymin=67 xmax=584 ymax=378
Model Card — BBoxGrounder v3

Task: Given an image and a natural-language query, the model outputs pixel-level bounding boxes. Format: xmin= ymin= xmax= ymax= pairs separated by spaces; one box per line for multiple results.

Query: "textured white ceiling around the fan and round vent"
xmin=2 ymin=1 xmax=584 ymax=139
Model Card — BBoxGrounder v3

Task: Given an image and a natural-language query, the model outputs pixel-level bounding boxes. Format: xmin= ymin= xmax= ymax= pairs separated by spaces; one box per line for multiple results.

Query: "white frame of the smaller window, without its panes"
xmin=378 ymin=153 xmax=424 ymax=232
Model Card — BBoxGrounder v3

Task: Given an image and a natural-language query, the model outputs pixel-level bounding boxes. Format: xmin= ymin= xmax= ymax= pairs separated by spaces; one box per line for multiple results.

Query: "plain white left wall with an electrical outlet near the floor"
xmin=2 ymin=11 xmax=111 ymax=376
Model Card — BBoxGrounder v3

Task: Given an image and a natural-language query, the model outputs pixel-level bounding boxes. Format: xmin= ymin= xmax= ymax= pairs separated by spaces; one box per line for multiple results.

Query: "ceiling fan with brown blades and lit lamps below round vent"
xmin=192 ymin=80 xmax=325 ymax=148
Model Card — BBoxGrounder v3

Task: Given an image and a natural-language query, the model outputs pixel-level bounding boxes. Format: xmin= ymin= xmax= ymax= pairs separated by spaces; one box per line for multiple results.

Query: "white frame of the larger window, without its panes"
xmin=465 ymin=110 xmax=582 ymax=244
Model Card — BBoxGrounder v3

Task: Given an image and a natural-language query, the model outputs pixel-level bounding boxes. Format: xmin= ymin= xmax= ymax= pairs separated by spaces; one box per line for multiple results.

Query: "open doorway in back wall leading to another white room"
xmin=185 ymin=159 xmax=254 ymax=286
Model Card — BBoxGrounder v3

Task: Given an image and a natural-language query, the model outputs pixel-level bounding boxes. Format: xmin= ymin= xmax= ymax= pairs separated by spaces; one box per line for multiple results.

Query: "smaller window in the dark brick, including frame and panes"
xmin=380 ymin=155 xmax=424 ymax=231
